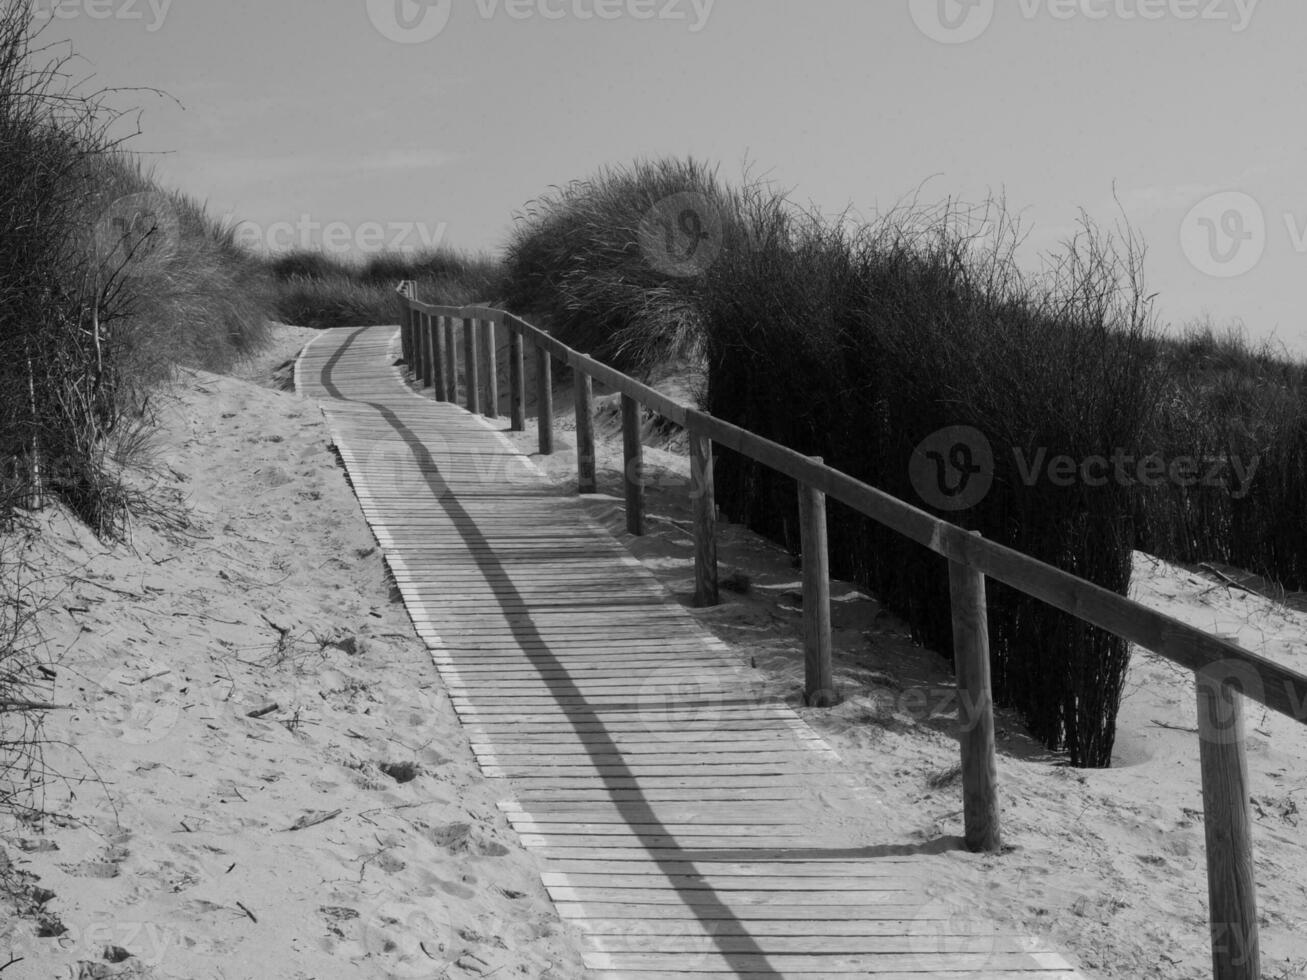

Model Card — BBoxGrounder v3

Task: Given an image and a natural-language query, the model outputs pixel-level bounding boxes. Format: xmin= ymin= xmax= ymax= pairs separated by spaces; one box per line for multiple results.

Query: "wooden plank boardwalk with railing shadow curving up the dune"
xmin=295 ymin=327 xmax=1081 ymax=980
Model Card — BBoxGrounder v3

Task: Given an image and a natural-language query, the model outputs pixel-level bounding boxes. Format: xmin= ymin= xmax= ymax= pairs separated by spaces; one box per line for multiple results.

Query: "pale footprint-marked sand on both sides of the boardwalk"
xmin=0 ymin=328 xmax=1307 ymax=980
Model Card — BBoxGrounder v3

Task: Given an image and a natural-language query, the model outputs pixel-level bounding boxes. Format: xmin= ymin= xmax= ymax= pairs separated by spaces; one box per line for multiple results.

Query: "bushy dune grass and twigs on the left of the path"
xmin=0 ymin=0 xmax=275 ymax=809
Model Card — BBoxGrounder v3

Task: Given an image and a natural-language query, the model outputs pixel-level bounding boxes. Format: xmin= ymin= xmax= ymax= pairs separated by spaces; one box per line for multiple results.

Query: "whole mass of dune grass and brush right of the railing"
xmin=506 ymin=159 xmax=1307 ymax=766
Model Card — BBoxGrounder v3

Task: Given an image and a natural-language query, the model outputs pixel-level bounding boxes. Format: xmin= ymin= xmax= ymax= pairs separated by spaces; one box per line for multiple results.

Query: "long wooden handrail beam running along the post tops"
xmin=406 ymin=299 xmax=1307 ymax=724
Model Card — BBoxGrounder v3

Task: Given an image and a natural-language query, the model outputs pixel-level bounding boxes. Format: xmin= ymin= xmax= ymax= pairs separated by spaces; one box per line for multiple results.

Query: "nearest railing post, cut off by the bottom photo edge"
xmin=1197 ymin=668 xmax=1261 ymax=980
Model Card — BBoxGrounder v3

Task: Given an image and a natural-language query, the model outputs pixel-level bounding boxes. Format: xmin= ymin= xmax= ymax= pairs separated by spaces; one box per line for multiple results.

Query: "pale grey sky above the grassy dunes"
xmin=35 ymin=0 xmax=1307 ymax=355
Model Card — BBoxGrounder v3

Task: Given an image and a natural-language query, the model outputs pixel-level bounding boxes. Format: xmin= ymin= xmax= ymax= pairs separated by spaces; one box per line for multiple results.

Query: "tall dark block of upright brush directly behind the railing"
xmin=702 ymin=188 xmax=1159 ymax=766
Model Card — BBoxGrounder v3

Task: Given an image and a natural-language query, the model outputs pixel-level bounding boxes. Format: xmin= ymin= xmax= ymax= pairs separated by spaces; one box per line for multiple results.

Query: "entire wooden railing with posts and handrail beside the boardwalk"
xmin=399 ymin=284 xmax=1307 ymax=980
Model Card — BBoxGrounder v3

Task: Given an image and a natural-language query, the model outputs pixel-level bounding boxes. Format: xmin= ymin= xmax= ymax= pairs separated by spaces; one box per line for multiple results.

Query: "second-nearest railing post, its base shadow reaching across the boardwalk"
xmin=949 ymin=533 xmax=1002 ymax=852
